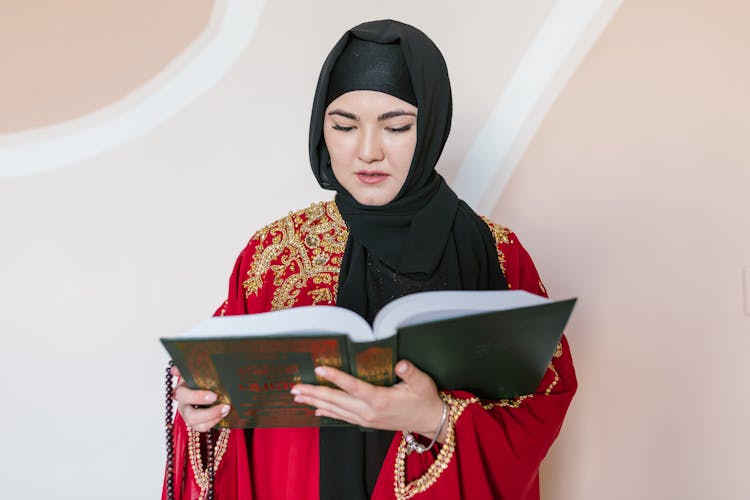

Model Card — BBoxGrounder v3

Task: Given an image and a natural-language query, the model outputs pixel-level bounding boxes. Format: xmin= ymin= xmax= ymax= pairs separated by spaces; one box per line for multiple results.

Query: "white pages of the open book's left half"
xmin=174 ymin=306 xmax=374 ymax=342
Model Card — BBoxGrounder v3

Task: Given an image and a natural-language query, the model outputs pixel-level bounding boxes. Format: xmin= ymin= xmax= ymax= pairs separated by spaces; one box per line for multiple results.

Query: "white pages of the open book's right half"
xmin=373 ymin=290 xmax=551 ymax=340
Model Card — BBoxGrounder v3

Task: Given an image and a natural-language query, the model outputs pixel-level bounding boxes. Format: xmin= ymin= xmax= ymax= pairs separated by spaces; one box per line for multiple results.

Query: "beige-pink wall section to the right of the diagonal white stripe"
xmin=493 ymin=0 xmax=750 ymax=500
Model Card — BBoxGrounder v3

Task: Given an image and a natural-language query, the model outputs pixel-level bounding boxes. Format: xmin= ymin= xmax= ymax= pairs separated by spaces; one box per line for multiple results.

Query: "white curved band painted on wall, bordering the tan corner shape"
xmin=0 ymin=0 xmax=265 ymax=177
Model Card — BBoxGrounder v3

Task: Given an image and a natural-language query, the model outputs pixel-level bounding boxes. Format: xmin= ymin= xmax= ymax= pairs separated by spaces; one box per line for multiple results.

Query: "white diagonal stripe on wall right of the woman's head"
xmin=451 ymin=0 xmax=622 ymax=213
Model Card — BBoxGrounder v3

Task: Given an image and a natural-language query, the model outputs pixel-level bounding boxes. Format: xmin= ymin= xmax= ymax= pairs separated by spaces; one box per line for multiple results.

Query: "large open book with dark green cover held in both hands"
xmin=161 ymin=290 xmax=575 ymax=427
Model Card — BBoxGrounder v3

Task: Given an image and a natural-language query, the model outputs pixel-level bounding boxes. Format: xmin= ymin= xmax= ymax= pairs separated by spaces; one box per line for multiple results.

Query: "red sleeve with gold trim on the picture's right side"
xmin=373 ymin=232 xmax=577 ymax=500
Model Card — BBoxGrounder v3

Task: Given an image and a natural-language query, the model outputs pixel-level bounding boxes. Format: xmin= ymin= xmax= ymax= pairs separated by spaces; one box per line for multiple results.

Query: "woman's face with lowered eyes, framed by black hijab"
xmin=323 ymin=90 xmax=417 ymax=206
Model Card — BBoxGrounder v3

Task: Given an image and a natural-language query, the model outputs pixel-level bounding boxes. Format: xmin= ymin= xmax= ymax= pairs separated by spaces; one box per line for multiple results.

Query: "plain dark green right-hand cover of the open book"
xmin=397 ymin=299 xmax=575 ymax=399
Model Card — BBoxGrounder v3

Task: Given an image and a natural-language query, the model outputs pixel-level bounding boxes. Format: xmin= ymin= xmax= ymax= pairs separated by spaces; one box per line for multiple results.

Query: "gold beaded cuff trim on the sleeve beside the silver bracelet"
xmin=393 ymin=392 xmax=479 ymax=500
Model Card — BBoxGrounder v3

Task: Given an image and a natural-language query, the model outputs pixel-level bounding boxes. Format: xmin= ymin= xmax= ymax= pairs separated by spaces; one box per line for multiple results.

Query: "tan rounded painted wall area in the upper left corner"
xmin=0 ymin=0 xmax=213 ymax=134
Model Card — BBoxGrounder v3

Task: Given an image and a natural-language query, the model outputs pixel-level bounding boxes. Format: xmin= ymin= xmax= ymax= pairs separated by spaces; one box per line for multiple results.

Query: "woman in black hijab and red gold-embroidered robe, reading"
xmin=163 ymin=21 xmax=576 ymax=499
